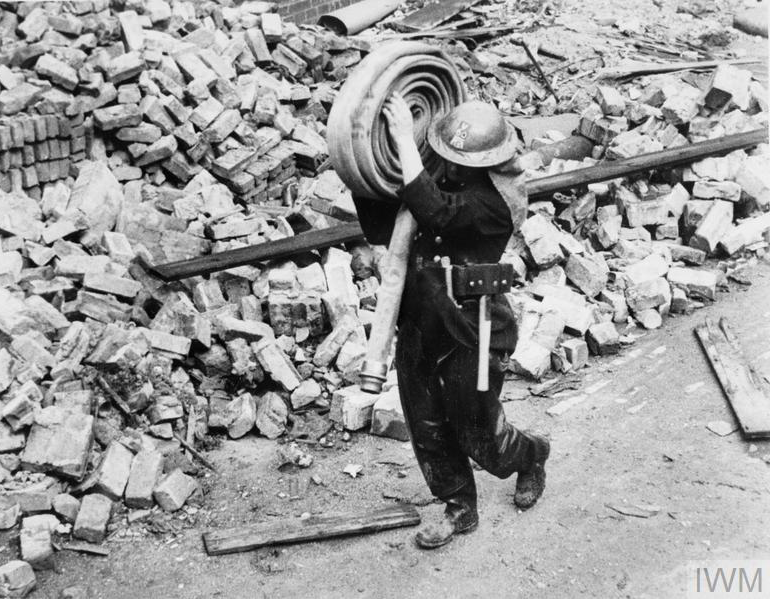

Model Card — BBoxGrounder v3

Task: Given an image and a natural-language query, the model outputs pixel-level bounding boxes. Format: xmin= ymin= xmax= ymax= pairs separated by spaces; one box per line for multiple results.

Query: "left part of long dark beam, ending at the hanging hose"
xmin=149 ymin=223 xmax=364 ymax=281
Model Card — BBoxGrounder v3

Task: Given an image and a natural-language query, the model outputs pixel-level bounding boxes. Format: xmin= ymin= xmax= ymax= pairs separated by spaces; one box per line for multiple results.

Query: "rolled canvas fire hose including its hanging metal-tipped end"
xmin=327 ymin=42 xmax=466 ymax=393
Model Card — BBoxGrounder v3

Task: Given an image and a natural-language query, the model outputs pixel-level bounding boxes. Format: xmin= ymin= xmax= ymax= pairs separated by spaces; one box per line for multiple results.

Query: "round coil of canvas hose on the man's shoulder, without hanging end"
xmin=327 ymin=41 xmax=465 ymax=201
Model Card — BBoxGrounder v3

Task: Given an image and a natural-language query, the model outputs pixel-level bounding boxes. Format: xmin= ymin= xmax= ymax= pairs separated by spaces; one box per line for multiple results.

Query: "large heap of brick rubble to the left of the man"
xmin=0 ymin=0 xmax=381 ymax=586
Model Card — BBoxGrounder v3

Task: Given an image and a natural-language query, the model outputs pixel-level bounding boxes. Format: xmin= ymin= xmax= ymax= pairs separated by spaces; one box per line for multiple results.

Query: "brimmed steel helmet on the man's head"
xmin=428 ymin=100 xmax=518 ymax=168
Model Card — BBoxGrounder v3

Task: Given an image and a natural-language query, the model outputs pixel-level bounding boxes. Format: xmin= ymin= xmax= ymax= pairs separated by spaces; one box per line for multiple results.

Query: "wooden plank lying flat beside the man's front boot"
xmin=203 ymin=505 xmax=420 ymax=555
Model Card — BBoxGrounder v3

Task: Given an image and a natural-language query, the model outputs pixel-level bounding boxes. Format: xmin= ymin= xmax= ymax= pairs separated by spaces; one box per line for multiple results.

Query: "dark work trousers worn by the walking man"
xmin=396 ymin=321 xmax=534 ymax=506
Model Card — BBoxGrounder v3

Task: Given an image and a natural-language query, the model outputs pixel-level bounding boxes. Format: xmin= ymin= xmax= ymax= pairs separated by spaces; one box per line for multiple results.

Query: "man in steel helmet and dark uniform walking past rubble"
xmin=355 ymin=93 xmax=550 ymax=549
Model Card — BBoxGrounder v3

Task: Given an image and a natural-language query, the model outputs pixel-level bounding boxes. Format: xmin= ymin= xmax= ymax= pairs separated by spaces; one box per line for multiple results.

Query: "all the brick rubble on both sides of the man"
xmin=0 ymin=0 xmax=770 ymax=584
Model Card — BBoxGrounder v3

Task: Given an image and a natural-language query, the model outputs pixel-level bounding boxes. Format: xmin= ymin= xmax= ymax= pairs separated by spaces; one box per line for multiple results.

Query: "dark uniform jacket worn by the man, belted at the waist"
xmin=354 ymin=171 xmax=516 ymax=366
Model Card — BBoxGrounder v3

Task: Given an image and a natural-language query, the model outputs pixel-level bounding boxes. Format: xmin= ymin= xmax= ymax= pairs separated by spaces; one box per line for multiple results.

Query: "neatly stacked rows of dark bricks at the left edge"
xmin=0 ymin=113 xmax=86 ymax=199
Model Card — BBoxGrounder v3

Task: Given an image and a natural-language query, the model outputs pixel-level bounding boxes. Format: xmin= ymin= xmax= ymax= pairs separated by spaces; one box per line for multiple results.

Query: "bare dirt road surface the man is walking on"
xmin=25 ymin=262 xmax=770 ymax=599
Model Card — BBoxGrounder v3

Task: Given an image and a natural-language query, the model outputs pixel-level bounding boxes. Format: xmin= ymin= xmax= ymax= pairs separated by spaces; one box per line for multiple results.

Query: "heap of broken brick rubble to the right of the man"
xmin=505 ymin=65 xmax=770 ymax=379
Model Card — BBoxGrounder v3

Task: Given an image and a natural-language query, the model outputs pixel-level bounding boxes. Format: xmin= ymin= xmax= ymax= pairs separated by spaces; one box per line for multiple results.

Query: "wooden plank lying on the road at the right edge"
xmin=695 ymin=318 xmax=770 ymax=439
